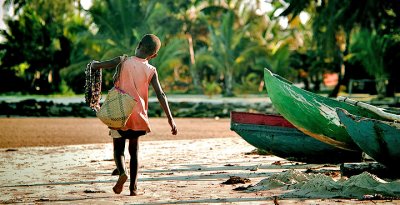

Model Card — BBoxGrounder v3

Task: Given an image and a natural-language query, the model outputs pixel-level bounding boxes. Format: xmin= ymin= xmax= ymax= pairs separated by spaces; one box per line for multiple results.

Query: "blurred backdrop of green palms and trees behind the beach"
xmin=0 ymin=0 xmax=400 ymax=98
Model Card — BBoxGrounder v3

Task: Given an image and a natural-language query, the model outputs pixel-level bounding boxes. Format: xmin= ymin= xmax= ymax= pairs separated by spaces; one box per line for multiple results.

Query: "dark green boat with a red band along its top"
xmin=231 ymin=112 xmax=361 ymax=163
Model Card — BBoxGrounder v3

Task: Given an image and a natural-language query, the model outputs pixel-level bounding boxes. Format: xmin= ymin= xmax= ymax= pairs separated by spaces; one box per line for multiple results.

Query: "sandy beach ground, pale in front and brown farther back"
xmin=0 ymin=118 xmax=400 ymax=204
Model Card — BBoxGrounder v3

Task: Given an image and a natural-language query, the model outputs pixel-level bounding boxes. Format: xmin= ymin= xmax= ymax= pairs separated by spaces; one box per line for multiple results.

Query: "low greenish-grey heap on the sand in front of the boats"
xmin=247 ymin=170 xmax=400 ymax=199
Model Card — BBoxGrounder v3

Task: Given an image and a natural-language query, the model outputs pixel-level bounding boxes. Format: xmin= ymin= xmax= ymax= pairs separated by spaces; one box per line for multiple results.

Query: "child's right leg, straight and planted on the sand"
xmin=129 ymin=137 xmax=139 ymax=196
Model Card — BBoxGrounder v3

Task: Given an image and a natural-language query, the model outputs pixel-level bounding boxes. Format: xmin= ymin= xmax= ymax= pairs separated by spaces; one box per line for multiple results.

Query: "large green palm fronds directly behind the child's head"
xmin=63 ymin=0 xmax=184 ymax=90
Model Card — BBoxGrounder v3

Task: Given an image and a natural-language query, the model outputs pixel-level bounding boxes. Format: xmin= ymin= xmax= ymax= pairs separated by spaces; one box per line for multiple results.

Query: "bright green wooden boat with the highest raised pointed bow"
xmin=264 ymin=69 xmax=381 ymax=150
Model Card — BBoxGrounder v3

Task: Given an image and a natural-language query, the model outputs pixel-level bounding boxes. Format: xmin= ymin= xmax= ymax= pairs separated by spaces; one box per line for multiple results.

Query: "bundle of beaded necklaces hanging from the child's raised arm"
xmin=85 ymin=61 xmax=102 ymax=111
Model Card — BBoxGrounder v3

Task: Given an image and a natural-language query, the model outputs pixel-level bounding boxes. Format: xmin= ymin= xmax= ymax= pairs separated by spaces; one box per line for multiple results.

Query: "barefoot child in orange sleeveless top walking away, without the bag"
xmin=92 ymin=34 xmax=178 ymax=196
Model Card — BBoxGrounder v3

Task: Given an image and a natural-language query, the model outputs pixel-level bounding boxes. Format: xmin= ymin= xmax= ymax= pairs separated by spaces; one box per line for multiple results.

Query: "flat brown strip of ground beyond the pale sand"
xmin=0 ymin=118 xmax=236 ymax=148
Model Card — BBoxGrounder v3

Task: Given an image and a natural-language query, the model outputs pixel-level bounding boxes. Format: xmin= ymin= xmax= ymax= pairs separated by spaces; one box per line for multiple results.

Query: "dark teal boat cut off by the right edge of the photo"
xmin=336 ymin=108 xmax=400 ymax=167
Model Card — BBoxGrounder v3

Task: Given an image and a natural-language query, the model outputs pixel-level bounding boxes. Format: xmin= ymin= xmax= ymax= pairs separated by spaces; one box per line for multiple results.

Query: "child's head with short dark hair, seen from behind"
xmin=136 ymin=34 xmax=161 ymax=59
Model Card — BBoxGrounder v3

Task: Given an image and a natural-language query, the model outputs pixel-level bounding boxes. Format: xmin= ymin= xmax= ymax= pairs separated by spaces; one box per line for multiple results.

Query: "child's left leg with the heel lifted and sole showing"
xmin=113 ymin=138 xmax=128 ymax=194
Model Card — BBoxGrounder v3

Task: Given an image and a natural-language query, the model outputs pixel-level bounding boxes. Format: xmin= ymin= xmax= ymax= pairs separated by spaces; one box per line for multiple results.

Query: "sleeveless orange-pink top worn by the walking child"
xmin=115 ymin=56 xmax=157 ymax=132
